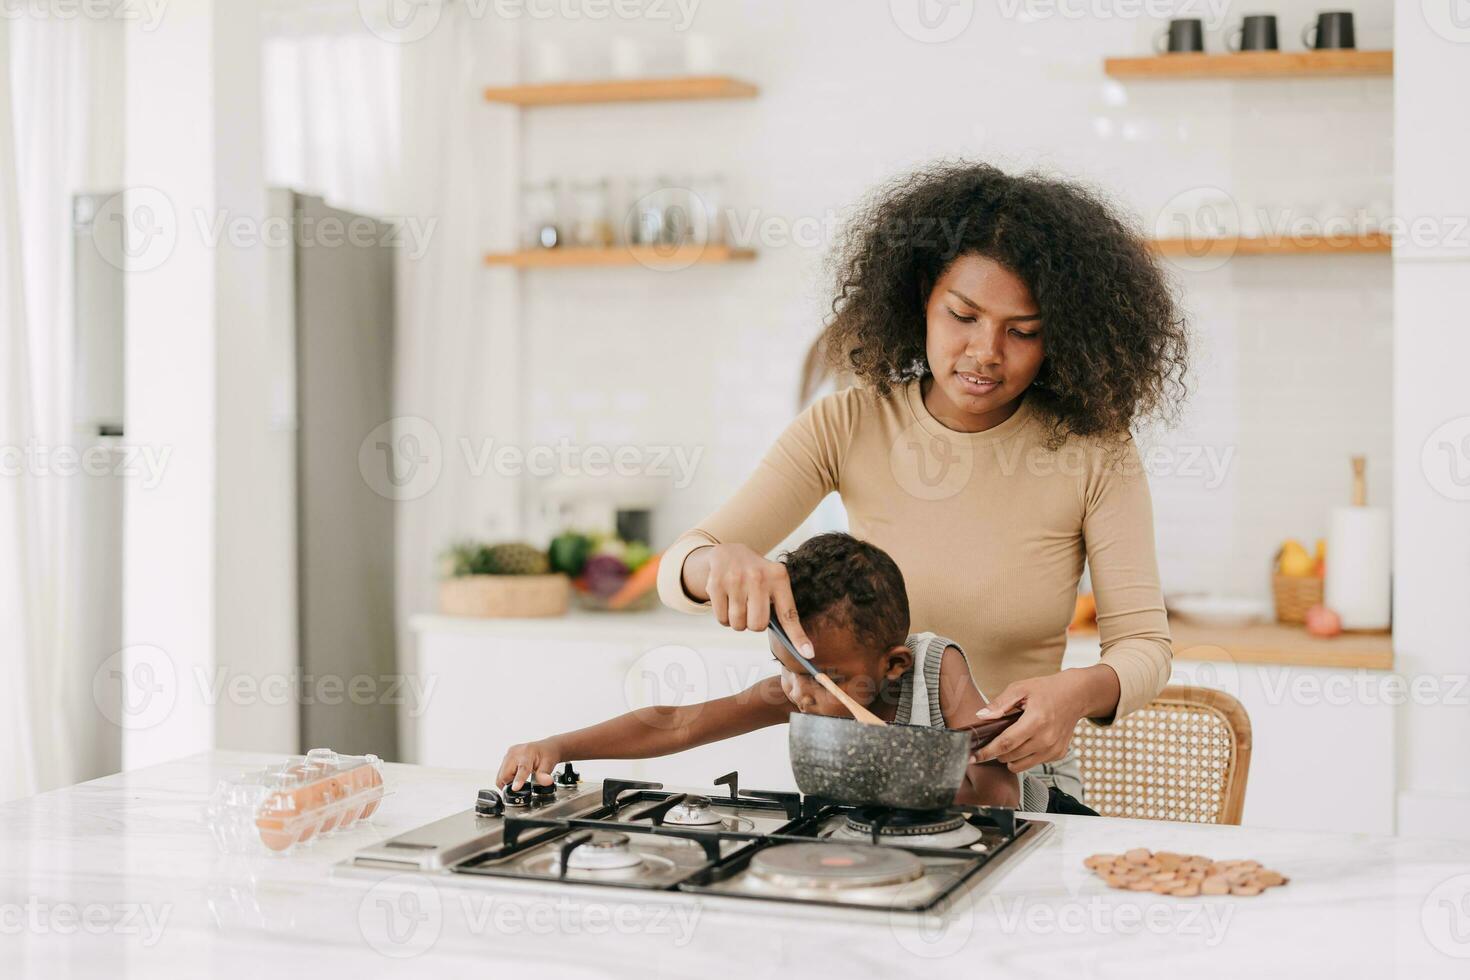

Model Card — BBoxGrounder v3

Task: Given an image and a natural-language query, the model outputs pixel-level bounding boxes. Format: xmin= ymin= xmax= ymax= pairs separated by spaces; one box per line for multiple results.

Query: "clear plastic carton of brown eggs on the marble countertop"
xmin=204 ymin=749 xmax=385 ymax=854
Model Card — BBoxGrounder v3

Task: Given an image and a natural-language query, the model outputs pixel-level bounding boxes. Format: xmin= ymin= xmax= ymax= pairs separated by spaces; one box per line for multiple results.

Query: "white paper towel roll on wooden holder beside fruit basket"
xmin=1323 ymin=507 xmax=1392 ymax=629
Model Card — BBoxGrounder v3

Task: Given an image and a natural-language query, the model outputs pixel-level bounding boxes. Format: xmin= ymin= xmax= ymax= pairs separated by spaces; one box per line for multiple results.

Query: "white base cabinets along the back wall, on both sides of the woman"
xmin=407 ymin=610 xmax=1395 ymax=833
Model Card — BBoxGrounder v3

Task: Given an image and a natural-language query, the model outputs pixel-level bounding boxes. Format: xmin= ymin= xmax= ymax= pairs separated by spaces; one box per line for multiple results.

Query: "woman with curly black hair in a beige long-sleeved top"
xmin=659 ymin=165 xmax=1188 ymax=810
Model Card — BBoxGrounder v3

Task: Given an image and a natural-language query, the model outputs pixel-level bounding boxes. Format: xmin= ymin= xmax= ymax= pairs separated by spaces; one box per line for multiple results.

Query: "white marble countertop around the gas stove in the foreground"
xmin=0 ymin=752 xmax=1470 ymax=980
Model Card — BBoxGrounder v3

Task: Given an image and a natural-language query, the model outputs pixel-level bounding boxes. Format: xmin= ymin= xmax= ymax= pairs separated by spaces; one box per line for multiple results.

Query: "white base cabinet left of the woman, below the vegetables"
xmin=413 ymin=611 xmax=795 ymax=789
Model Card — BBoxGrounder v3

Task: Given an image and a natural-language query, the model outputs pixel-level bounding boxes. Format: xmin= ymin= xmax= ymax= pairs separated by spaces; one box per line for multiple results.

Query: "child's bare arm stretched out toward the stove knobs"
xmin=495 ymin=676 xmax=795 ymax=789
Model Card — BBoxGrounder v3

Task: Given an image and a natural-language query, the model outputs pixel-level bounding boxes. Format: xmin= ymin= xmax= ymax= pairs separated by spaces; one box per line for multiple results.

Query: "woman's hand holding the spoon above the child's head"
xmin=684 ymin=544 xmax=813 ymax=660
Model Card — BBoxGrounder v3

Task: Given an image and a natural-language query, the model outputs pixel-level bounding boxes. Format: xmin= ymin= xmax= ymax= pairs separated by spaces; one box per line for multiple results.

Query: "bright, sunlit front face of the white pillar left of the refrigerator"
xmin=122 ymin=3 xmax=216 ymax=768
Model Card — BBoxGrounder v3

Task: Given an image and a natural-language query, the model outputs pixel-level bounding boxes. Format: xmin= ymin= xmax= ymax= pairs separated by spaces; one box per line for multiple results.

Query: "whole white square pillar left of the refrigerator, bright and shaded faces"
xmin=122 ymin=0 xmax=295 ymax=768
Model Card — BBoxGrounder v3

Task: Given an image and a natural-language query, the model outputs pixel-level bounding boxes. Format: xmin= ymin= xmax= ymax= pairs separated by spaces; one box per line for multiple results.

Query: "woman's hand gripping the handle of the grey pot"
xmin=973 ymin=664 xmax=1119 ymax=773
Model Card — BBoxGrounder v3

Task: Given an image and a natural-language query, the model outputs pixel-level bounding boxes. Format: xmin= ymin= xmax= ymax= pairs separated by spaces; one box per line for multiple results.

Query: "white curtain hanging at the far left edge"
xmin=0 ymin=11 xmax=122 ymax=799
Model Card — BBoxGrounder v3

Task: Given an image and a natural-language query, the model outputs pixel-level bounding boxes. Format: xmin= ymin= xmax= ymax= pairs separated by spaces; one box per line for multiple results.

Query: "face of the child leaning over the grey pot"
xmin=767 ymin=620 xmax=913 ymax=718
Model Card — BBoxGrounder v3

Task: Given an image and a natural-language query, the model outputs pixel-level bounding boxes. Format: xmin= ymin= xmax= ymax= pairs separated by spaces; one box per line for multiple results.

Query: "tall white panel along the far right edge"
xmin=1394 ymin=4 xmax=1470 ymax=837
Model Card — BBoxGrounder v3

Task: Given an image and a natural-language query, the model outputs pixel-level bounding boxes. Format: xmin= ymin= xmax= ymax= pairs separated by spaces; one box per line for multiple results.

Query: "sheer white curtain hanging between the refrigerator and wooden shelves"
xmin=394 ymin=4 xmax=522 ymax=761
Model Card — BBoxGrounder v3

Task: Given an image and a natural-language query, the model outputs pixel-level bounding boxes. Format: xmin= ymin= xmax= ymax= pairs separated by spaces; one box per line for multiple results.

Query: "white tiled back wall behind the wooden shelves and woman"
xmin=511 ymin=0 xmax=1394 ymax=597
